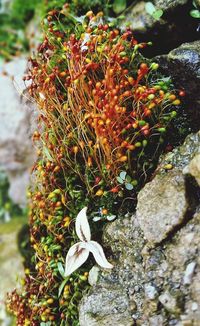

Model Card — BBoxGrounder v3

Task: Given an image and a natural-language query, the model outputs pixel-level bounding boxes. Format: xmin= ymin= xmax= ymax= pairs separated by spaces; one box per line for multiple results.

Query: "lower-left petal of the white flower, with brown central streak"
xmin=64 ymin=242 xmax=89 ymax=276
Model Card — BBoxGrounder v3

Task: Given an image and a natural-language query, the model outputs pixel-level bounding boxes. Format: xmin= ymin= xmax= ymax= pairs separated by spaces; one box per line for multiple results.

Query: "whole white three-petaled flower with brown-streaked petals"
xmin=65 ymin=207 xmax=113 ymax=276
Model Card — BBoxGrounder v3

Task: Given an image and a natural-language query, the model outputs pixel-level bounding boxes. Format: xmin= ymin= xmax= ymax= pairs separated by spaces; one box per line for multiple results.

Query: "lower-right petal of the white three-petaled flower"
xmin=85 ymin=241 xmax=113 ymax=268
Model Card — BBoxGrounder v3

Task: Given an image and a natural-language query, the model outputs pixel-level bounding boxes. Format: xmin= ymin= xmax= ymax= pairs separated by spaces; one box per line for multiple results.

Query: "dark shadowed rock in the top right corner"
xmin=122 ymin=0 xmax=199 ymax=57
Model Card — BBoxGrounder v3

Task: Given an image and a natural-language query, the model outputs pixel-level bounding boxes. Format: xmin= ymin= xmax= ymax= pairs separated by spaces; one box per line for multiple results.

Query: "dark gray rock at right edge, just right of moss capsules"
xmin=155 ymin=40 xmax=200 ymax=124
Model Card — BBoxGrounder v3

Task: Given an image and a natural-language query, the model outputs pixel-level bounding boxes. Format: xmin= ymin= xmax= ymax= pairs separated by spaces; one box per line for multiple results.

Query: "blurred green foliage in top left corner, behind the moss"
xmin=0 ymin=0 xmax=112 ymax=60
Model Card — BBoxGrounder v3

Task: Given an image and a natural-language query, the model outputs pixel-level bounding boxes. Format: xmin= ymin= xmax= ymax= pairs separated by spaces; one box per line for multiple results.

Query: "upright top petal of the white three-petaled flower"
xmin=76 ymin=207 xmax=91 ymax=241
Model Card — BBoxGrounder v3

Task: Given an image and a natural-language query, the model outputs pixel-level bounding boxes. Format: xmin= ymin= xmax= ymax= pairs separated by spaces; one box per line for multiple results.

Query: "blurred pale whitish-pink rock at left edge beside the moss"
xmin=0 ymin=58 xmax=35 ymax=204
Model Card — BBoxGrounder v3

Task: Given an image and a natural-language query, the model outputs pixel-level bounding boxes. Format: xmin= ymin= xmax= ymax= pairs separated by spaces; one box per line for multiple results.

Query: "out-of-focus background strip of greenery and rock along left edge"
xmin=0 ymin=0 xmax=42 ymax=326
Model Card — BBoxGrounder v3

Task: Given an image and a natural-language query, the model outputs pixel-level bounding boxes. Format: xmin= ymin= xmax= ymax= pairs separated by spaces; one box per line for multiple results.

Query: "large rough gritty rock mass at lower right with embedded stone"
xmin=80 ymin=133 xmax=200 ymax=326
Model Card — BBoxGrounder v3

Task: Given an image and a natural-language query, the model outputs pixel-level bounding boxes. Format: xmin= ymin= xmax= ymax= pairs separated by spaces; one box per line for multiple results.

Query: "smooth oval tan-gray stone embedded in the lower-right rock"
xmin=137 ymin=171 xmax=188 ymax=243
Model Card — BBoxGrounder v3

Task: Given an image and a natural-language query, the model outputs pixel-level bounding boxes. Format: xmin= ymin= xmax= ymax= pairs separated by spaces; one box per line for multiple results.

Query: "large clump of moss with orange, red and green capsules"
xmin=8 ymin=5 xmax=184 ymax=326
